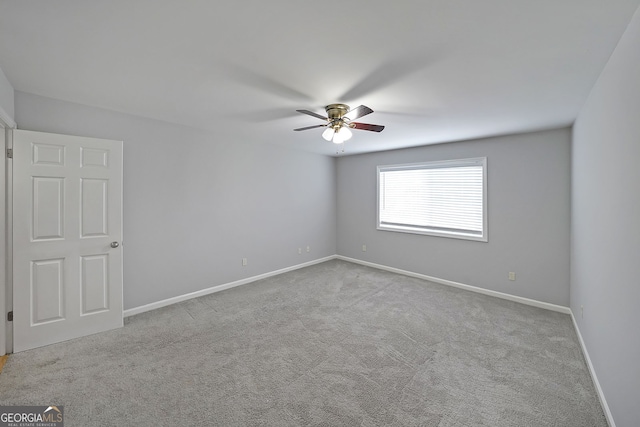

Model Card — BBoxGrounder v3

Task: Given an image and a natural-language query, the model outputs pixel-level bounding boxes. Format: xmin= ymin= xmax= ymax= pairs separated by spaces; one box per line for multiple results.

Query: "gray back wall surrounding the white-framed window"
xmin=337 ymin=129 xmax=571 ymax=306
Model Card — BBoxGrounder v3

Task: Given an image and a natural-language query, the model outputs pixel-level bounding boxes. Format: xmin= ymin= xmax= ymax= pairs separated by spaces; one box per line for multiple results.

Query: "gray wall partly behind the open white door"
xmin=15 ymin=91 xmax=336 ymax=308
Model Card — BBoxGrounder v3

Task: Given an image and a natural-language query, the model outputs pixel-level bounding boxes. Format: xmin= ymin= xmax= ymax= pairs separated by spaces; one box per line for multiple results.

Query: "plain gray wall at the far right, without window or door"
xmin=571 ymin=4 xmax=640 ymax=427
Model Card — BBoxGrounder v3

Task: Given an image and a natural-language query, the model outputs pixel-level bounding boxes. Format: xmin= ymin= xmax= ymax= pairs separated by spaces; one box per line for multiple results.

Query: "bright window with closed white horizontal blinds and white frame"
xmin=378 ymin=157 xmax=488 ymax=242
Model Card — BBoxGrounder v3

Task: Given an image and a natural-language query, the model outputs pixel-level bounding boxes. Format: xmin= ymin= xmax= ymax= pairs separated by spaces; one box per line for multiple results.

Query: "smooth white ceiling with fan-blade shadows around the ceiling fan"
xmin=0 ymin=0 xmax=640 ymax=155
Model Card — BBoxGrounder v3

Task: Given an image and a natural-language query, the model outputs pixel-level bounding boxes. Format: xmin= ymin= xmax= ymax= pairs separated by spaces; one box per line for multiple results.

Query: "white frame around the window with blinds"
xmin=376 ymin=157 xmax=489 ymax=242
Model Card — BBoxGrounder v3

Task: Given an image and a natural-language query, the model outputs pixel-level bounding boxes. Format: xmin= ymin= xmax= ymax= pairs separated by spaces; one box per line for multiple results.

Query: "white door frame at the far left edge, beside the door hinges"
xmin=0 ymin=106 xmax=17 ymax=356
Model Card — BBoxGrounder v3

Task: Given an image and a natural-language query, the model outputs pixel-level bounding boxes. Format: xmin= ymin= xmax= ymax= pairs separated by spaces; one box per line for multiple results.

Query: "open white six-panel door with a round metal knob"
xmin=13 ymin=130 xmax=123 ymax=352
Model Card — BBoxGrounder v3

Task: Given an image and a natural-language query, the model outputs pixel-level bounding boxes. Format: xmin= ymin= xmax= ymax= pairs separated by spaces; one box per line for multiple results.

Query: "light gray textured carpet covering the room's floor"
xmin=0 ymin=261 xmax=607 ymax=427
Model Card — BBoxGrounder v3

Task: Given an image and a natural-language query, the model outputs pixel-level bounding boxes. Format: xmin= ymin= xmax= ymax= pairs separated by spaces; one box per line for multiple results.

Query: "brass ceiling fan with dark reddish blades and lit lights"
xmin=294 ymin=104 xmax=384 ymax=144
